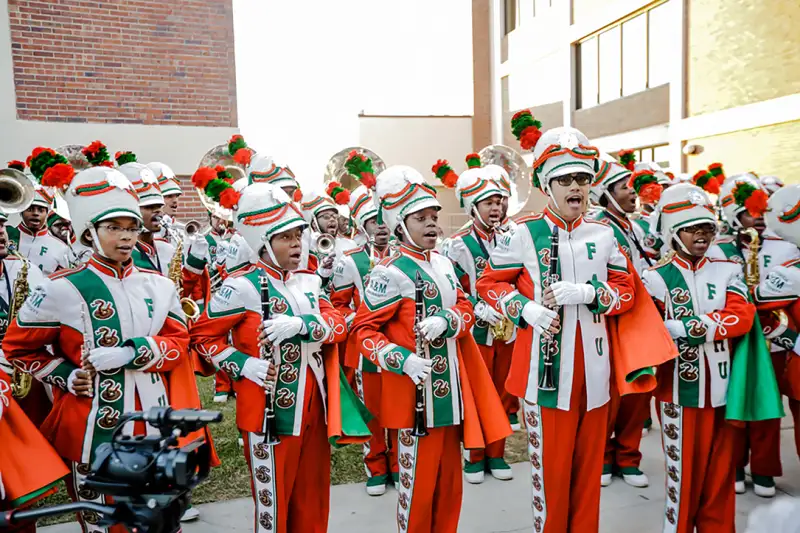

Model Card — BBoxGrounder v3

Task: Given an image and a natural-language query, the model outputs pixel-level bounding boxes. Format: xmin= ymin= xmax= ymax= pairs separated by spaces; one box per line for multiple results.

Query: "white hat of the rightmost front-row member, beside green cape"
xmin=650 ymin=183 xmax=717 ymax=246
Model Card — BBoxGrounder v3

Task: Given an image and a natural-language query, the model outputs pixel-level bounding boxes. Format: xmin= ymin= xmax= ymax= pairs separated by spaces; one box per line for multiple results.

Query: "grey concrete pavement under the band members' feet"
xmin=41 ymin=418 xmax=800 ymax=533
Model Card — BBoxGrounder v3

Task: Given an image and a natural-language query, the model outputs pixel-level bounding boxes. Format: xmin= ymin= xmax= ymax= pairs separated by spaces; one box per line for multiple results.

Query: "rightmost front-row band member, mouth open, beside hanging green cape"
xmin=644 ymin=183 xmax=755 ymax=533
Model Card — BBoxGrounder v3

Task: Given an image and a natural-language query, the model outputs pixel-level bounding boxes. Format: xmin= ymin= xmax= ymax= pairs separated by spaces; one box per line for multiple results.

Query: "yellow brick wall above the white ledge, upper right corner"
xmin=688 ymin=0 xmax=800 ymax=116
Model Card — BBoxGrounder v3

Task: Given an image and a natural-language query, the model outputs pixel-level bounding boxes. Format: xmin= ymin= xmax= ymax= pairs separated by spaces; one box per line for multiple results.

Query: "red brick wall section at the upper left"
xmin=8 ymin=0 xmax=237 ymax=127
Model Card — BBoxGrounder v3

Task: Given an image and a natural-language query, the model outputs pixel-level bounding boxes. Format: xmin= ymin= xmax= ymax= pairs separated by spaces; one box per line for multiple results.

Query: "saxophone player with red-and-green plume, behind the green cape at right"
xmin=708 ymin=175 xmax=800 ymax=498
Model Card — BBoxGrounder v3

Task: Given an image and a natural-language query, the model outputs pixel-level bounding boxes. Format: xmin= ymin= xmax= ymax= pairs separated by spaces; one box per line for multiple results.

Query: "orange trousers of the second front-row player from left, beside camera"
xmin=243 ymin=371 xmax=331 ymax=533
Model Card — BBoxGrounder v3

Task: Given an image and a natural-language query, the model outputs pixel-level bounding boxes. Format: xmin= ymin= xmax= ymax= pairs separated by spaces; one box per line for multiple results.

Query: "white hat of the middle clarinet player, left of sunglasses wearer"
xmin=375 ymin=165 xmax=442 ymax=233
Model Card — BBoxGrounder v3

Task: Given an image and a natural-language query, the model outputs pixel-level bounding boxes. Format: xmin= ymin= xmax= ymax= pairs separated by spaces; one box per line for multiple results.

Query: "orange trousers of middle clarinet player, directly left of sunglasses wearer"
xmin=397 ymin=426 xmax=462 ymax=533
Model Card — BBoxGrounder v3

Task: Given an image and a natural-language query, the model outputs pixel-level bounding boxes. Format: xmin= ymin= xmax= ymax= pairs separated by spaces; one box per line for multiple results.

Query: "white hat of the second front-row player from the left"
xmin=233 ymin=183 xmax=308 ymax=264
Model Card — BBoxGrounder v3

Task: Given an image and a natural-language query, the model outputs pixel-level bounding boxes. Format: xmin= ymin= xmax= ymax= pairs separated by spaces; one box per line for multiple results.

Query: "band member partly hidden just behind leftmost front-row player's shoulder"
xmin=116 ymin=152 xmax=175 ymax=276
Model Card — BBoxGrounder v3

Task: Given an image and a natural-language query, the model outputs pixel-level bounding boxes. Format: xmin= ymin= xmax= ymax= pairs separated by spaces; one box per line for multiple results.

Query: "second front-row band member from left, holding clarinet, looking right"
xmin=192 ymin=184 xmax=367 ymax=533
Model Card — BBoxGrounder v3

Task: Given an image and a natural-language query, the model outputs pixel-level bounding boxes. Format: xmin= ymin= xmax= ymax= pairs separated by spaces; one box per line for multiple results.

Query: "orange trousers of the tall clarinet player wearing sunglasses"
xmin=524 ymin=336 xmax=608 ymax=533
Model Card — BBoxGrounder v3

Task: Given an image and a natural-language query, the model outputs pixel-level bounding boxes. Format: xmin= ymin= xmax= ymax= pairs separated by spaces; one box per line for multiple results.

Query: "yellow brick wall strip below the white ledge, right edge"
xmin=688 ymin=121 xmax=800 ymax=184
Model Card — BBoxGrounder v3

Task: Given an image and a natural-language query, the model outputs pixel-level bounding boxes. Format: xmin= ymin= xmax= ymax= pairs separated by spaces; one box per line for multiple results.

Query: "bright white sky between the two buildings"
xmin=233 ymin=0 xmax=473 ymax=186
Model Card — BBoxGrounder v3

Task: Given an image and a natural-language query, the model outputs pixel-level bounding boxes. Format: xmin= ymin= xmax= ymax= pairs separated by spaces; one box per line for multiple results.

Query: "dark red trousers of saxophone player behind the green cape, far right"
xmin=734 ymin=352 xmax=786 ymax=477
